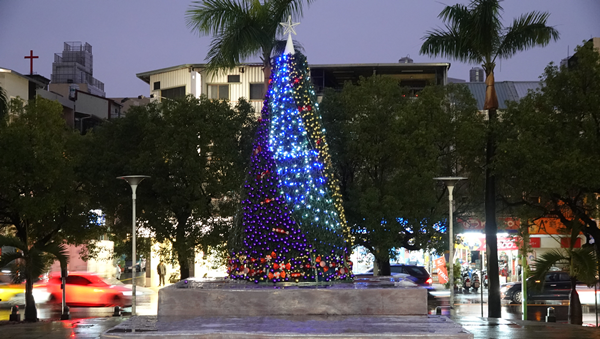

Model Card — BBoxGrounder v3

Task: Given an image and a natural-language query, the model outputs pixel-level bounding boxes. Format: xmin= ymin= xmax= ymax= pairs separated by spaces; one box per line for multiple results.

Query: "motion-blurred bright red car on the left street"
xmin=33 ymin=272 xmax=132 ymax=307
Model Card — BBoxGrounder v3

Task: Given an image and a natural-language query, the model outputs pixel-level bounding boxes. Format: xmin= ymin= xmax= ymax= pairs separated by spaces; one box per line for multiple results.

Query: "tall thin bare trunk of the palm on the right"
xmin=483 ymin=63 xmax=502 ymax=318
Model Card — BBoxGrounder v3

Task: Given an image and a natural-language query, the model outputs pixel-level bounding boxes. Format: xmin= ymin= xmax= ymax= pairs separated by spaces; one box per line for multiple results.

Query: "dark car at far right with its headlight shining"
xmin=500 ymin=271 xmax=571 ymax=304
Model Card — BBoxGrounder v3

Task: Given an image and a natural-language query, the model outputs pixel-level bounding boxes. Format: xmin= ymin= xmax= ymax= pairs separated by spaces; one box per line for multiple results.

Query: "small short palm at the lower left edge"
xmin=0 ymin=235 xmax=69 ymax=321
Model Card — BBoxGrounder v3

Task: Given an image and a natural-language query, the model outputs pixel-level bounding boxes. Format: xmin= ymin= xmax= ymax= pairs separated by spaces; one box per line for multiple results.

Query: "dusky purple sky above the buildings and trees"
xmin=0 ymin=0 xmax=600 ymax=97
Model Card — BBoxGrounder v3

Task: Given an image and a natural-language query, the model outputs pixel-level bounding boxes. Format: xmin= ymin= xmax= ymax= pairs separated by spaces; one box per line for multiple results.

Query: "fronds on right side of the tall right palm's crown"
xmin=497 ymin=11 xmax=560 ymax=59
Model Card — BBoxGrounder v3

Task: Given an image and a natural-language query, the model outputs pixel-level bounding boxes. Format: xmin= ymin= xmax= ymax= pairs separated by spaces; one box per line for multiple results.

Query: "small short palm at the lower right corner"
xmin=533 ymin=246 xmax=596 ymax=325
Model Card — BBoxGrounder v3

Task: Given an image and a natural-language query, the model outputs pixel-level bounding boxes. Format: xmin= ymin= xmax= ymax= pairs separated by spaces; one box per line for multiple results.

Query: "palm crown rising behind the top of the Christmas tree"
xmin=186 ymin=0 xmax=313 ymax=90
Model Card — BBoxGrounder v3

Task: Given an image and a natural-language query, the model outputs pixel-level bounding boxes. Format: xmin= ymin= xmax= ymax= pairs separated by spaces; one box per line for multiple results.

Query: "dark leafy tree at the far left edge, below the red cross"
xmin=0 ymin=98 xmax=97 ymax=321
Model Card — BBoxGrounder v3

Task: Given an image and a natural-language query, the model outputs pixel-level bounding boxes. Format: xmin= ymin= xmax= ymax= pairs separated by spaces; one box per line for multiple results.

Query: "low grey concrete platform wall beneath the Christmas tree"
xmin=158 ymin=286 xmax=427 ymax=321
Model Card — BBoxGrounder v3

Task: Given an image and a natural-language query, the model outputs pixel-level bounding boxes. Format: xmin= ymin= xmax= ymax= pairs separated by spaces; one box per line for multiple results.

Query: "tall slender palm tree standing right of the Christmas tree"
xmin=420 ymin=0 xmax=559 ymax=318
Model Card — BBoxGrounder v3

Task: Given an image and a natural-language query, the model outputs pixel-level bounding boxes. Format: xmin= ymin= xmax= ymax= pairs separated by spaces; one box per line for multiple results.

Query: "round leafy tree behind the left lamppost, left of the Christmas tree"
xmin=84 ymin=96 xmax=254 ymax=279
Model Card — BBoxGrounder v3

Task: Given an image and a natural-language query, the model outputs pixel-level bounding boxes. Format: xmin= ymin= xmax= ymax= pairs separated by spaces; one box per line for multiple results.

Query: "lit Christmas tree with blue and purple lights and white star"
xmin=228 ymin=18 xmax=352 ymax=283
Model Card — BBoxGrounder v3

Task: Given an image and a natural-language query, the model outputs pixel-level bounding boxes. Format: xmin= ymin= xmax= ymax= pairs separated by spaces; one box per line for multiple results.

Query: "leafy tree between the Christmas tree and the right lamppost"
xmin=320 ymin=76 xmax=482 ymax=275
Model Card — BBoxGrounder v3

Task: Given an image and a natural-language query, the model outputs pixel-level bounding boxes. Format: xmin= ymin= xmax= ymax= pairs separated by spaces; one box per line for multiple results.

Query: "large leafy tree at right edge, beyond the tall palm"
xmin=496 ymin=42 xmax=600 ymax=298
